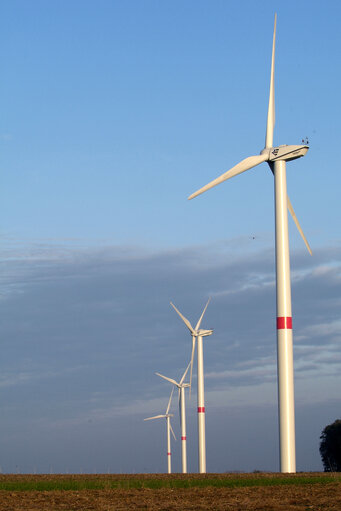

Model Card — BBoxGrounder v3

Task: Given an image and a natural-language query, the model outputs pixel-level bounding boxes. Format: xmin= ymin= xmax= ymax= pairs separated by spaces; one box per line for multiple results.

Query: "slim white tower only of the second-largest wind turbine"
xmin=197 ymin=335 xmax=206 ymax=474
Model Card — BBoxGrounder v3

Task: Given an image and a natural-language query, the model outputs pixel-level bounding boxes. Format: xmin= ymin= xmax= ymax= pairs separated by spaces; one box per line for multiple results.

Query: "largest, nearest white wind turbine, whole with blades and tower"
xmin=189 ymin=15 xmax=311 ymax=472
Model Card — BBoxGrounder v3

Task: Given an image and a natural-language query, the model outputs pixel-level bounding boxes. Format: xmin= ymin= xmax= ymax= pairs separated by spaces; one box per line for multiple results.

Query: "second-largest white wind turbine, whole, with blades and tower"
xmin=171 ymin=299 xmax=213 ymax=474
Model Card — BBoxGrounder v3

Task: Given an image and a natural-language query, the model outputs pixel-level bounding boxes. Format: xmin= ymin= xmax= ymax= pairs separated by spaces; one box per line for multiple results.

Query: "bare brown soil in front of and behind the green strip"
xmin=0 ymin=474 xmax=341 ymax=511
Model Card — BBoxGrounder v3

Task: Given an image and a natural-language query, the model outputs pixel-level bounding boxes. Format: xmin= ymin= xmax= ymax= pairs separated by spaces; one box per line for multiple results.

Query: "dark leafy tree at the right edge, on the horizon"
xmin=320 ymin=420 xmax=341 ymax=472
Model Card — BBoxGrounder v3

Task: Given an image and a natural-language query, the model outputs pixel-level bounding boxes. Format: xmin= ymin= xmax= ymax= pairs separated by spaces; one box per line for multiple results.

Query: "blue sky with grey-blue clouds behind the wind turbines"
xmin=0 ymin=0 xmax=341 ymax=472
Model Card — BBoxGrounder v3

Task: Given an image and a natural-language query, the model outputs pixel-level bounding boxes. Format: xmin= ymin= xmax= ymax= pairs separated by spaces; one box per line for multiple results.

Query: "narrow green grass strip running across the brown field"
xmin=0 ymin=476 xmax=341 ymax=491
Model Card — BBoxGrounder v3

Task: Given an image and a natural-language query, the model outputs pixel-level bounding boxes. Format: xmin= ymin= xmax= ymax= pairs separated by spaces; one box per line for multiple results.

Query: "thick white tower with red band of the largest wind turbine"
xmin=274 ymin=161 xmax=296 ymax=472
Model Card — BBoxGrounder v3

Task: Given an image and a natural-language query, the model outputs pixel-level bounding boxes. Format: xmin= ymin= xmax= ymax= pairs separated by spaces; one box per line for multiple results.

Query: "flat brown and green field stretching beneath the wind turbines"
xmin=0 ymin=473 xmax=341 ymax=511
